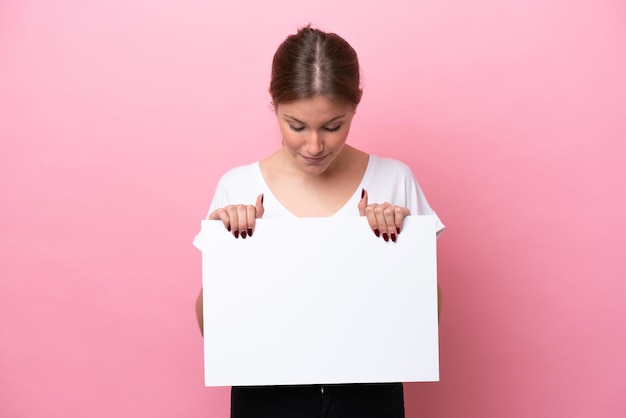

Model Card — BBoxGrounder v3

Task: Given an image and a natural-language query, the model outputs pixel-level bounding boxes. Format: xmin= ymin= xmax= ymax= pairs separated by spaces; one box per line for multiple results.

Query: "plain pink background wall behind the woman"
xmin=0 ymin=0 xmax=626 ymax=418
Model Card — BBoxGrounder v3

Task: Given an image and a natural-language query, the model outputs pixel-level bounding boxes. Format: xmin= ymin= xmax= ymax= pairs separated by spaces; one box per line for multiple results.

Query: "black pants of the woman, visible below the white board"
xmin=231 ymin=383 xmax=404 ymax=418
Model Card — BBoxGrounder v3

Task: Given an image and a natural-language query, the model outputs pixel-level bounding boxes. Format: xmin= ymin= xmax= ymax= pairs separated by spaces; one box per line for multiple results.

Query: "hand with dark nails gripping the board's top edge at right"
xmin=359 ymin=189 xmax=411 ymax=242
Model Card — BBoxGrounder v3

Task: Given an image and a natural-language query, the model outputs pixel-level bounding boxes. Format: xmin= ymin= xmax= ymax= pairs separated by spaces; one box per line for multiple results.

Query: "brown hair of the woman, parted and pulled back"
xmin=269 ymin=25 xmax=362 ymax=108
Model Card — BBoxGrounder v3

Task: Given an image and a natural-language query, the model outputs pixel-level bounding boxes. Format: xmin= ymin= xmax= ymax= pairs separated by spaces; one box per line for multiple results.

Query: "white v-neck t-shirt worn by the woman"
xmin=194 ymin=155 xmax=445 ymax=247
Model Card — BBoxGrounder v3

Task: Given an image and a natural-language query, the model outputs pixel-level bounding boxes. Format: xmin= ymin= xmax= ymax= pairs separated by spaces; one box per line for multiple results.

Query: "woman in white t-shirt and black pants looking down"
xmin=196 ymin=26 xmax=444 ymax=418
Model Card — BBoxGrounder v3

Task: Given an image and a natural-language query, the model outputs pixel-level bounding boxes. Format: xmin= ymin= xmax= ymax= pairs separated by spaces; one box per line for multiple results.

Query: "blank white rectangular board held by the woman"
xmin=197 ymin=216 xmax=439 ymax=386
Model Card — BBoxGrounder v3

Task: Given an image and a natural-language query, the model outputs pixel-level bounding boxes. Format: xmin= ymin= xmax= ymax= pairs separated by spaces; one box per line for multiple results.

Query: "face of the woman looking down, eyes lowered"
xmin=276 ymin=96 xmax=355 ymax=176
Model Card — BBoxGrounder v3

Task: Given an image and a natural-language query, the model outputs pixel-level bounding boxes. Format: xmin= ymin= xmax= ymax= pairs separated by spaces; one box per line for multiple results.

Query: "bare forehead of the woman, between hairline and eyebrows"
xmin=276 ymin=96 xmax=354 ymax=122
